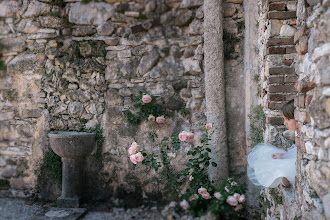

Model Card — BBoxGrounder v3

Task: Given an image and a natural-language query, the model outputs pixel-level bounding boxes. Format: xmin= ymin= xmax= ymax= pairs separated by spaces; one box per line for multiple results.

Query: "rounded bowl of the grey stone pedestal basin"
xmin=48 ymin=131 xmax=95 ymax=158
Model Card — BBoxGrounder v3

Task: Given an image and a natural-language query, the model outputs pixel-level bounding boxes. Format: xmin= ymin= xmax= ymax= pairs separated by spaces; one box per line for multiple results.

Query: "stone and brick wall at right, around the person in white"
xmin=259 ymin=0 xmax=330 ymax=219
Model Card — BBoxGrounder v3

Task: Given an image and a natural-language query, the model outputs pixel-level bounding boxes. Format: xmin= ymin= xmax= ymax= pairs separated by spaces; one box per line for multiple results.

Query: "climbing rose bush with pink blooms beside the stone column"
xmin=128 ymin=93 xmax=246 ymax=219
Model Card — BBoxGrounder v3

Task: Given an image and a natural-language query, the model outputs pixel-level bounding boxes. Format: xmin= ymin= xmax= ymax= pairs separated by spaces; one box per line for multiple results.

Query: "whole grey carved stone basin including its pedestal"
xmin=48 ymin=131 xmax=95 ymax=208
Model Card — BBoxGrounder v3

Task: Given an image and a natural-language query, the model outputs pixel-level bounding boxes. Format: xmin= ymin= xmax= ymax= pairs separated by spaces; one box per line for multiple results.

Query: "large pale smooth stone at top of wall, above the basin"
xmin=69 ymin=2 xmax=114 ymax=25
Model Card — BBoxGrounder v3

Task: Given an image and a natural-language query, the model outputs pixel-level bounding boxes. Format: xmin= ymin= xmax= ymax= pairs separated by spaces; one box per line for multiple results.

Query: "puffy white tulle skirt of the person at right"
xmin=247 ymin=143 xmax=297 ymax=188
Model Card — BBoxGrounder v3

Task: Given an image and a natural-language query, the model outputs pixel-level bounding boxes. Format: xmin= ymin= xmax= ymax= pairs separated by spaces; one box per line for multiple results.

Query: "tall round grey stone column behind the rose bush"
xmin=204 ymin=0 xmax=228 ymax=184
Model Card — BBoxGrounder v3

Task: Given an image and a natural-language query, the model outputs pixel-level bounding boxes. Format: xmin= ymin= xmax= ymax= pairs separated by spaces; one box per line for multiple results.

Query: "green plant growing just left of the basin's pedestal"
xmin=42 ymin=149 xmax=62 ymax=181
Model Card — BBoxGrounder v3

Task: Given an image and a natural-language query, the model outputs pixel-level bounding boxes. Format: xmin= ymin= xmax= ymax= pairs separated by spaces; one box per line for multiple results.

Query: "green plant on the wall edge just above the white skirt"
xmin=248 ymin=105 xmax=266 ymax=146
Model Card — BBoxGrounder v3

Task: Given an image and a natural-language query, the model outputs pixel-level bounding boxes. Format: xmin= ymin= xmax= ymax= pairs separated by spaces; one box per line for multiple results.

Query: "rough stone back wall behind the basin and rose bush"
xmin=0 ymin=0 xmax=245 ymax=203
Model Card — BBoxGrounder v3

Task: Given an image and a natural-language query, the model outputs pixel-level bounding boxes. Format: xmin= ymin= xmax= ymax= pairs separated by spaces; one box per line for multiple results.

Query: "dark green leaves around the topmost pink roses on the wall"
xmin=124 ymin=91 xmax=163 ymax=125
